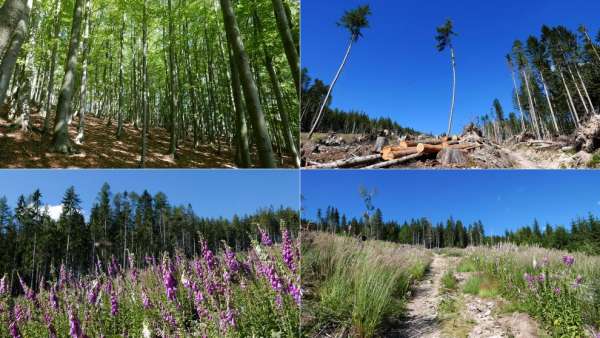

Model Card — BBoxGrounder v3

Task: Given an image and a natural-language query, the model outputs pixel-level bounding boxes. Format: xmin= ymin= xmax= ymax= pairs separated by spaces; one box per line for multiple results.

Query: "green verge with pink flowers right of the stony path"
xmin=465 ymin=245 xmax=600 ymax=337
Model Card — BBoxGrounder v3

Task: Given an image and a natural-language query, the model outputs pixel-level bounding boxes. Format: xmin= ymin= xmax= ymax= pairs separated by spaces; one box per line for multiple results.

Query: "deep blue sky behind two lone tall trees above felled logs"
xmin=302 ymin=0 xmax=600 ymax=133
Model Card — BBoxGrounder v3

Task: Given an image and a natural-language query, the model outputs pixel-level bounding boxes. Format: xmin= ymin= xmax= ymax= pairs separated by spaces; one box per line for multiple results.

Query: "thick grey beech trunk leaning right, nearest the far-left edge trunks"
xmin=52 ymin=0 xmax=83 ymax=153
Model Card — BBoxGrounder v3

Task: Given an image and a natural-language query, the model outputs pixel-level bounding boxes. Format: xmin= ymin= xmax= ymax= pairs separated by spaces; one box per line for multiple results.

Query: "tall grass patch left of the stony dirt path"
xmin=302 ymin=233 xmax=431 ymax=337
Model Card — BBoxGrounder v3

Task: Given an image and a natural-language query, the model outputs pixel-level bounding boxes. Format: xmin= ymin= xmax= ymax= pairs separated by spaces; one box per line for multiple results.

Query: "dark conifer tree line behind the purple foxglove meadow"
xmin=0 ymin=183 xmax=299 ymax=294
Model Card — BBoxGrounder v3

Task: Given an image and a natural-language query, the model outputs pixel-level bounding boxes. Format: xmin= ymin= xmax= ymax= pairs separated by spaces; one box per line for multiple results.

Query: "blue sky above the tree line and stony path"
xmin=302 ymin=170 xmax=600 ymax=234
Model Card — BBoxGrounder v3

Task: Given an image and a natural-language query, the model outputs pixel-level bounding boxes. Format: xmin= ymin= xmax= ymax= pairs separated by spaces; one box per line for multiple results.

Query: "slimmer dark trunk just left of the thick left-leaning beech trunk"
xmin=229 ymin=48 xmax=250 ymax=168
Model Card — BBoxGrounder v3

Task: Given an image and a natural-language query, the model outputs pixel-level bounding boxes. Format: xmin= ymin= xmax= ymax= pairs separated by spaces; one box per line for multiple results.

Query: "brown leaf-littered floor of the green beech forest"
xmin=0 ymin=114 xmax=294 ymax=168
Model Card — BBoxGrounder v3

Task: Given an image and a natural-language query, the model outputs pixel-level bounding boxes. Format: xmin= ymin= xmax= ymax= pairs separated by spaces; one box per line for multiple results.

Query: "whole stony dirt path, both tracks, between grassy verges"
xmin=394 ymin=253 xmax=545 ymax=338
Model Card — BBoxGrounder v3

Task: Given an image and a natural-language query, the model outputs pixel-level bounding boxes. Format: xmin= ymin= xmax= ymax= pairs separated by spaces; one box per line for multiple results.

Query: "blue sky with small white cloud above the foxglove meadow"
xmin=0 ymin=170 xmax=300 ymax=218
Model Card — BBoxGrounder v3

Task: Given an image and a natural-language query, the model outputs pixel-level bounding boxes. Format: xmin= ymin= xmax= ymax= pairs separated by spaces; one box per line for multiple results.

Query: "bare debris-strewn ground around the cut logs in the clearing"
xmin=301 ymin=133 xmax=597 ymax=169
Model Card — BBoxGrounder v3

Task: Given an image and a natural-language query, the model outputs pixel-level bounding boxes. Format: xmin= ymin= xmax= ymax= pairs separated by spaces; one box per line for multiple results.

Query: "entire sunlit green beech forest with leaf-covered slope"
xmin=0 ymin=0 xmax=300 ymax=167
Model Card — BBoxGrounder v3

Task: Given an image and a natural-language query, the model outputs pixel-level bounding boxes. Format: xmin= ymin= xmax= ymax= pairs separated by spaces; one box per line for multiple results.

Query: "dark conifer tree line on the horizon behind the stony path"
xmin=302 ymin=206 xmax=600 ymax=254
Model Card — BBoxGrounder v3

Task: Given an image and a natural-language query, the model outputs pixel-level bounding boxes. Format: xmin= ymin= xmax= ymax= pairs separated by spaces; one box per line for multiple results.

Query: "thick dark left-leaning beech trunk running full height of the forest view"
xmin=220 ymin=0 xmax=276 ymax=168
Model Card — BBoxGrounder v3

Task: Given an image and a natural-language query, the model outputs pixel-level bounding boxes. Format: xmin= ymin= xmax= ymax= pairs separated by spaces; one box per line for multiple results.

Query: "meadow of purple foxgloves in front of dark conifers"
xmin=0 ymin=230 xmax=302 ymax=338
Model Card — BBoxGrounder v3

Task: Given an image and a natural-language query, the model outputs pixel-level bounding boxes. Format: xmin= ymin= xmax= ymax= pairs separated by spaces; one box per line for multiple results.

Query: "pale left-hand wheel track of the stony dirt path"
xmin=395 ymin=254 xmax=449 ymax=338
